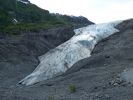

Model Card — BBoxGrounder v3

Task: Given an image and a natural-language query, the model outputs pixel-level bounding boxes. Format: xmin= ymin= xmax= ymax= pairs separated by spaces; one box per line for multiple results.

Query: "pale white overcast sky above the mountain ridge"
xmin=29 ymin=0 xmax=133 ymax=23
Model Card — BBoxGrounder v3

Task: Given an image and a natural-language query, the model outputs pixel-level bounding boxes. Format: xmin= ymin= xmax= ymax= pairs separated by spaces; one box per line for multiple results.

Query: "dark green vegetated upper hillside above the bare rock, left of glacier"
xmin=0 ymin=0 xmax=88 ymax=35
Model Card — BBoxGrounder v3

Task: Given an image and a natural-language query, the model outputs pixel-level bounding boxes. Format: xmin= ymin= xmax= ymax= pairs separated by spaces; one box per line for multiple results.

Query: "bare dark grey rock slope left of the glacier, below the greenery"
xmin=0 ymin=23 xmax=91 ymax=100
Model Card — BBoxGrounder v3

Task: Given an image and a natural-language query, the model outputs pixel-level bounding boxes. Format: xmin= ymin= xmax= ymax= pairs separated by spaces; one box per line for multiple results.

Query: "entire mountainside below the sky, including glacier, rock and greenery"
xmin=0 ymin=0 xmax=133 ymax=100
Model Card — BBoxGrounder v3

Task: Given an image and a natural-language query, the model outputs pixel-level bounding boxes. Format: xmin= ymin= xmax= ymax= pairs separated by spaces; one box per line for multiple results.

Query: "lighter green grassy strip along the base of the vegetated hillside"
xmin=0 ymin=21 xmax=70 ymax=35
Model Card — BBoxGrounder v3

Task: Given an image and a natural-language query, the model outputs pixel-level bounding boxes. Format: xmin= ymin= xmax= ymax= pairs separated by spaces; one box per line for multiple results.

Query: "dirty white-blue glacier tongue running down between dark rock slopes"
xmin=19 ymin=21 xmax=122 ymax=86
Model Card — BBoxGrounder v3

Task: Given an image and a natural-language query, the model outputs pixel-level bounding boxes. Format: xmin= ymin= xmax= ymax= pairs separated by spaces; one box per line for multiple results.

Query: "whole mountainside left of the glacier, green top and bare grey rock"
xmin=0 ymin=0 xmax=93 ymax=100
